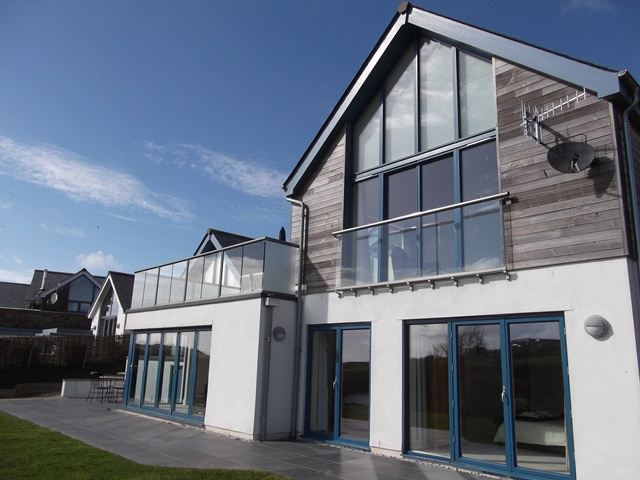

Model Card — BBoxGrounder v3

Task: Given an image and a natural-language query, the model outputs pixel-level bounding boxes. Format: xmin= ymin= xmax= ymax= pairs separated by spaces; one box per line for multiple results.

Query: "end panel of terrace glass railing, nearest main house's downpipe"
xmin=262 ymin=242 xmax=298 ymax=295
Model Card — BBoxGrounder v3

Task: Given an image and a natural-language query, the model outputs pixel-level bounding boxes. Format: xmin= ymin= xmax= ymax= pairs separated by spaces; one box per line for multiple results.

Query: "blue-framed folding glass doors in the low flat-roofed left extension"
xmin=125 ymin=330 xmax=211 ymax=420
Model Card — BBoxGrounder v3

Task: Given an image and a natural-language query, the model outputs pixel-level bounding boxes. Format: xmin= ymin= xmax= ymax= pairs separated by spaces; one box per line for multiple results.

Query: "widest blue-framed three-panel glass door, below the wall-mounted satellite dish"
xmin=406 ymin=316 xmax=574 ymax=478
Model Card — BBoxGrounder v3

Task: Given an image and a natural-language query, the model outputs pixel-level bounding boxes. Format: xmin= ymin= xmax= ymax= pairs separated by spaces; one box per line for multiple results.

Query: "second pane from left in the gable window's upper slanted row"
xmin=384 ymin=47 xmax=416 ymax=162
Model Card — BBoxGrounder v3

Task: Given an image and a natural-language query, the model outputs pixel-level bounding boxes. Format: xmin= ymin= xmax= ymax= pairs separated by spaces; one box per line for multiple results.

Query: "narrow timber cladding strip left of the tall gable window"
xmin=291 ymin=131 xmax=346 ymax=293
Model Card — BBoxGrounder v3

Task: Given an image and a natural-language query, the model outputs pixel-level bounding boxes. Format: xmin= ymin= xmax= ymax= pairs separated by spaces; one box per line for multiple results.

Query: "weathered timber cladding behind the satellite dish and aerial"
xmin=495 ymin=60 xmax=628 ymax=269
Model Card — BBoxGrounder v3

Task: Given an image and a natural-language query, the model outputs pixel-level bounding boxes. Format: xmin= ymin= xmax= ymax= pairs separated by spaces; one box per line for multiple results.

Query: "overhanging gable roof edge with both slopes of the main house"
xmin=282 ymin=2 xmax=631 ymax=195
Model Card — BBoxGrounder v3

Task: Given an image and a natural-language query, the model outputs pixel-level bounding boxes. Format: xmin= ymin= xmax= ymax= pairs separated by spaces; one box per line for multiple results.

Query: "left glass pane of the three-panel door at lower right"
xmin=409 ymin=324 xmax=449 ymax=457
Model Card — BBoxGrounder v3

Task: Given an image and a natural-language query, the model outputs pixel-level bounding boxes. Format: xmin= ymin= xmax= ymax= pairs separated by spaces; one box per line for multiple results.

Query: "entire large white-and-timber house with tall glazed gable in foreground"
xmin=125 ymin=2 xmax=640 ymax=480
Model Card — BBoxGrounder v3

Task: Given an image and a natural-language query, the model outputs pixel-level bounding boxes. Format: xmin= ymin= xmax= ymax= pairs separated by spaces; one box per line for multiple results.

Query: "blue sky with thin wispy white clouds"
xmin=0 ymin=0 xmax=640 ymax=282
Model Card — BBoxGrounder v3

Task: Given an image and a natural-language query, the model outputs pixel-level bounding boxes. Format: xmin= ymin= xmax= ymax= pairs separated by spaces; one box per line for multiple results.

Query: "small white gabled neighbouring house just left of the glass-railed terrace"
xmin=87 ymin=271 xmax=133 ymax=337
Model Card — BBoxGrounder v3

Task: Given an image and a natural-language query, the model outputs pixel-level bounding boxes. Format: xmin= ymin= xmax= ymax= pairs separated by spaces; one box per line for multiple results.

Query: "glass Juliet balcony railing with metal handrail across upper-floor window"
xmin=333 ymin=192 xmax=509 ymax=288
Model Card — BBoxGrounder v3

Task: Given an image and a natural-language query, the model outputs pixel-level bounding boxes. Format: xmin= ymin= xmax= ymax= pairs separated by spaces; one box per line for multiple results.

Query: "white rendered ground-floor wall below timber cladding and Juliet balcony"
xmin=298 ymin=258 xmax=640 ymax=480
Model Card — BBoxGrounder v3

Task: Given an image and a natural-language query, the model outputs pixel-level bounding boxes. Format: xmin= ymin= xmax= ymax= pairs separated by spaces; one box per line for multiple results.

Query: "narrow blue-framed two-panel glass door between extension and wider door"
xmin=305 ymin=324 xmax=371 ymax=447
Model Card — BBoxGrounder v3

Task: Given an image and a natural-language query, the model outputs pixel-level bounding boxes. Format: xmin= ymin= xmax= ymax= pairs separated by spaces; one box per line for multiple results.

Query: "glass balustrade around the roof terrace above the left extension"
xmin=131 ymin=238 xmax=298 ymax=309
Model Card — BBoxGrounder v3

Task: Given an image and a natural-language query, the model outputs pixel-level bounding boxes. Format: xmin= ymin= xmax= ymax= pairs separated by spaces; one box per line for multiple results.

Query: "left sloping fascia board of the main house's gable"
xmin=283 ymin=14 xmax=407 ymax=194
